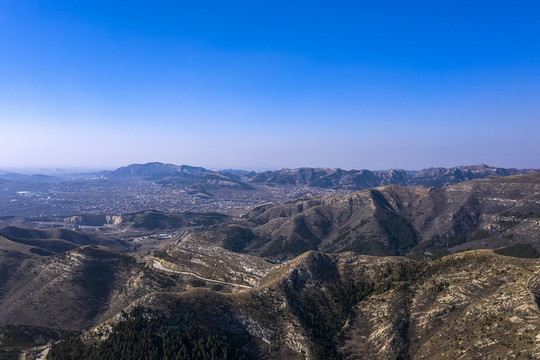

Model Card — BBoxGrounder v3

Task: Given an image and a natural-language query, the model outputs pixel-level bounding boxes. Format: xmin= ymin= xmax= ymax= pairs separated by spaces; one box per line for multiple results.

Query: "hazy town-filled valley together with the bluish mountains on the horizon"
xmin=0 ymin=163 xmax=534 ymax=219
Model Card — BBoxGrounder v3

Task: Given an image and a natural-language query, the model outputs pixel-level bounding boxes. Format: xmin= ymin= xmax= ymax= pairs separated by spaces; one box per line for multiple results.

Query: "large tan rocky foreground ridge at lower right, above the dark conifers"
xmin=51 ymin=250 xmax=540 ymax=359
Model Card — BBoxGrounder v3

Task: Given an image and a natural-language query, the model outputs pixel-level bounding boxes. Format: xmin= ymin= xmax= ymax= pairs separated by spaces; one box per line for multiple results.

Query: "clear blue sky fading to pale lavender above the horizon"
xmin=0 ymin=0 xmax=540 ymax=169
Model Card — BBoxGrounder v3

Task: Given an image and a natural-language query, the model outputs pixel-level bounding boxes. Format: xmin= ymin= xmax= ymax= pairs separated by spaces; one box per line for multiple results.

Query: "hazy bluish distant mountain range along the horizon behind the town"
xmin=0 ymin=162 xmax=537 ymax=192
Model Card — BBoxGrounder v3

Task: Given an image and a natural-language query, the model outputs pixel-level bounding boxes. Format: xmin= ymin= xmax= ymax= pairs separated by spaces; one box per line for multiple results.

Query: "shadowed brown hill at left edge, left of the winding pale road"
xmin=0 ymin=246 xmax=225 ymax=330
